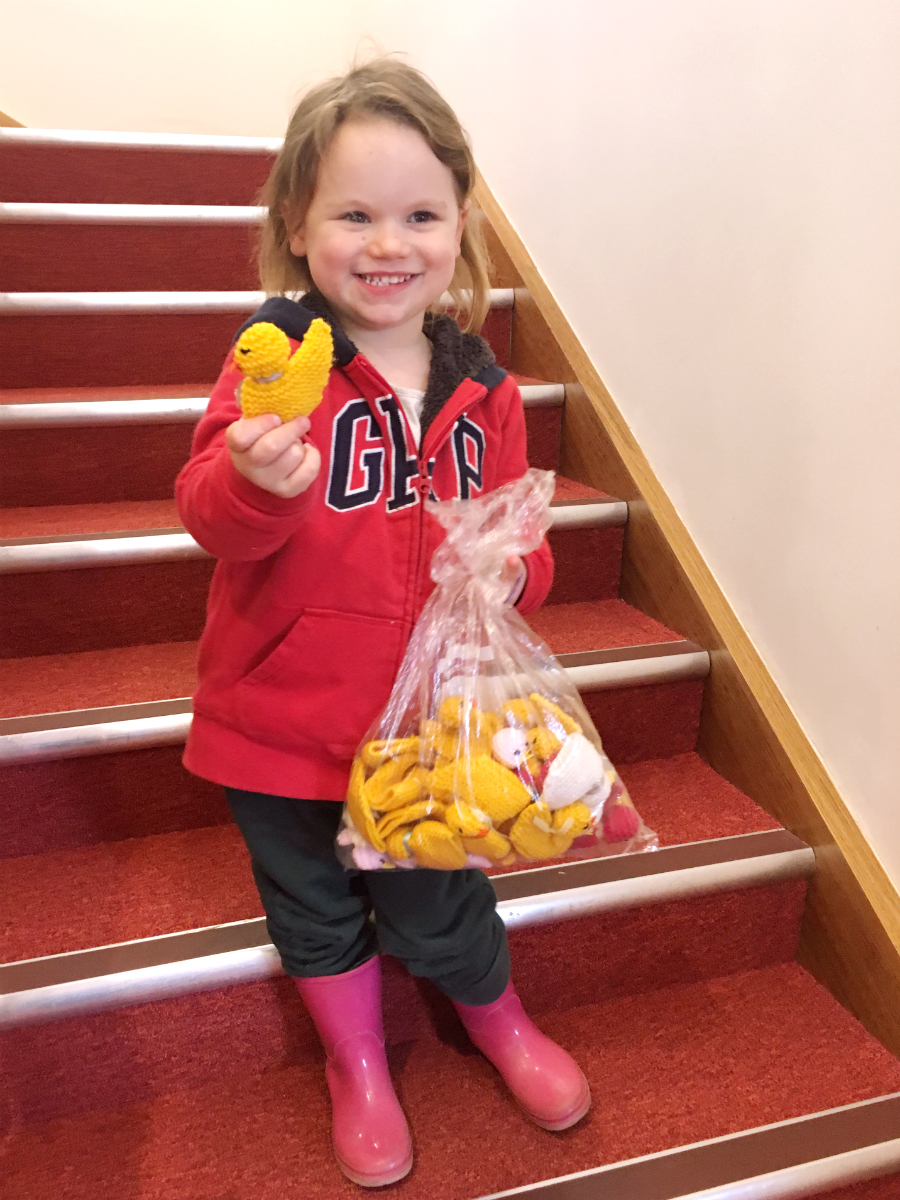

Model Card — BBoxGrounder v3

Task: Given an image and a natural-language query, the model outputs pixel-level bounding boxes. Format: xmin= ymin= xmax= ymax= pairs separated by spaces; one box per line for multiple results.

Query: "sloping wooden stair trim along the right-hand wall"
xmin=476 ymin=179 xmax=900 ymax=1054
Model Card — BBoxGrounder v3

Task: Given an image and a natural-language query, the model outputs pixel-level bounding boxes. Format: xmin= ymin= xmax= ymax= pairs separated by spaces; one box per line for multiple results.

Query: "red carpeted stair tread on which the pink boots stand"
xmin=4 ymin=964 xmax=900 ymax=1200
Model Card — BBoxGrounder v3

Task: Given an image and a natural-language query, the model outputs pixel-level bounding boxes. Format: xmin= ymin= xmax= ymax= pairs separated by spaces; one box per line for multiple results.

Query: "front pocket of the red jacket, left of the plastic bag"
xmin=236 ymin=608 xmax=406 ymax=761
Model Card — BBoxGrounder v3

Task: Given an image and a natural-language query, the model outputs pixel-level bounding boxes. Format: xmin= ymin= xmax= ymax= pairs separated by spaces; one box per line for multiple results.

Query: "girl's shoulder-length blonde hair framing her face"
xmin=257 ymin=55 xmax=491 ymax=332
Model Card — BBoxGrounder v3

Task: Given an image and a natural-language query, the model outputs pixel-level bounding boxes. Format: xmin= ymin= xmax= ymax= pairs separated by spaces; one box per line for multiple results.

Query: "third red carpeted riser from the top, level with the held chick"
xmin=0 ymin=308 xmax=511 ymax=388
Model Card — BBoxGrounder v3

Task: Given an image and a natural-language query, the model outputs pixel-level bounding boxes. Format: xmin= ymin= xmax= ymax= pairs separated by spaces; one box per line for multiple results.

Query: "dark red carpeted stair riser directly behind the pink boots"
xmin=0 ymin=912 xmax=811 ymax=1124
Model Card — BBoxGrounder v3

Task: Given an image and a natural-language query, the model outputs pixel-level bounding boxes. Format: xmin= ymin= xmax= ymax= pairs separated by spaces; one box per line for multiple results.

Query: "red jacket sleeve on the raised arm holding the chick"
xmin=175 ymin=355 xmax=312 ymax=563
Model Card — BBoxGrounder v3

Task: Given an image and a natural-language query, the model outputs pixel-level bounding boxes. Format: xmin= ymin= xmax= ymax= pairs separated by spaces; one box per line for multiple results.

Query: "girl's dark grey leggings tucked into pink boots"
xmin=226 ymin=787 xmax=509 ymax=1004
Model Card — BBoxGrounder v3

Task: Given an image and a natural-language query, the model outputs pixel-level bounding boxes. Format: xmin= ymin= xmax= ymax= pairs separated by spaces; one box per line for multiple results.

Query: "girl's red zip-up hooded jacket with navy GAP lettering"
xmin=175 ymin=294 xmax=553 ymax=800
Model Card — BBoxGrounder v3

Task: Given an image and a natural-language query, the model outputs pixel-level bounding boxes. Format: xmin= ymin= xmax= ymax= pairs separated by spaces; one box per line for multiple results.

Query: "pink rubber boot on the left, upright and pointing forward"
xmin=294 ymin=958 xmax=413 ymax=1188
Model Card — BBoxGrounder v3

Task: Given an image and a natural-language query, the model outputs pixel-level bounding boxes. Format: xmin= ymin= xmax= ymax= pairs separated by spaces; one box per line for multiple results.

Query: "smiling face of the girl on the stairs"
xmin=289 ymin=118 xmax=466 ymax=336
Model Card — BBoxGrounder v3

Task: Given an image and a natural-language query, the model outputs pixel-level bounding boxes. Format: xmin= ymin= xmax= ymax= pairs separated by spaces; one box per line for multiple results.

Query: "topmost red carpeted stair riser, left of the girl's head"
xmin=0 ymin=142 xmax=274 ymax=204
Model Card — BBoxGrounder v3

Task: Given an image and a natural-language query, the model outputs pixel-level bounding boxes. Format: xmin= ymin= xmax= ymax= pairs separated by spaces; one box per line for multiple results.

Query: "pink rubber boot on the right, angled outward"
xmin=454 ymin=983 xmax=590 ymax=1130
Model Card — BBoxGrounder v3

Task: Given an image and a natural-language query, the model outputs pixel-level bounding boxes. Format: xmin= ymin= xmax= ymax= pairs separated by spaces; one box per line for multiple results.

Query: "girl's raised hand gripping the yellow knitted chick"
xmin=226 ymin=413 xmax=322 ymax=500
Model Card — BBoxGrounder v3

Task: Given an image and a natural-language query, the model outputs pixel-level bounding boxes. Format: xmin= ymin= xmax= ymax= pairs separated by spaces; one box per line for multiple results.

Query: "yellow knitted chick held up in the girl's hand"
xmin=234 ymin=317 xmax=334 ymax=421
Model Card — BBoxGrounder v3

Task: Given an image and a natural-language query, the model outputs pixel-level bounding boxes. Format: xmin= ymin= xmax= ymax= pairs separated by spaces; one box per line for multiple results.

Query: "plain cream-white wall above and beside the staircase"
xmin=7 ymin=0 xmax=900 ymax=884
